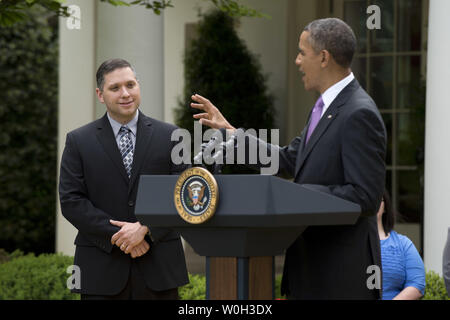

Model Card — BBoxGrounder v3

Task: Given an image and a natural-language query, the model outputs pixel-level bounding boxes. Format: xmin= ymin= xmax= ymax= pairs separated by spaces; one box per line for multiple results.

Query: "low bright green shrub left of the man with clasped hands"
xmin=0 ymin=252 xmax=79 ymax=300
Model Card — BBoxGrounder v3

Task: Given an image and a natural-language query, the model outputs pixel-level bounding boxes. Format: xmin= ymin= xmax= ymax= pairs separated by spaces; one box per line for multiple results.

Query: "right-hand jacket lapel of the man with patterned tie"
xmin=128 ymin=111 xmax=153 ymax=191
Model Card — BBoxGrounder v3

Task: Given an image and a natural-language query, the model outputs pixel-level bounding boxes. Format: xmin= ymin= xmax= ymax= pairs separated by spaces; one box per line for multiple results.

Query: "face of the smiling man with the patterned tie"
xmin=96 ymin=67 xmax=141 ymax=124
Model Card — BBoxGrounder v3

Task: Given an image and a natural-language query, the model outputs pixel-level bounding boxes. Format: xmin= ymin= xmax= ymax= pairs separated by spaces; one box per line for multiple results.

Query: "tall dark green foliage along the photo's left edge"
xmin=0 ymin=7 xmax=58 ymax=253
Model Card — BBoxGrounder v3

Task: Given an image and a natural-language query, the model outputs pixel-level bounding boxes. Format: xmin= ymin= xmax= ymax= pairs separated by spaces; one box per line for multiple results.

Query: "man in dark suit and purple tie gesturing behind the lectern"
xmin=191 ymin=18 xmax=386 ymax=299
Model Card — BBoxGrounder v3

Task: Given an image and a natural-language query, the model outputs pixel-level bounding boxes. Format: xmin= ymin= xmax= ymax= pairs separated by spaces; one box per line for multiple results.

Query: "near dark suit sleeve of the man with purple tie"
xmin=305 ymin=108 xmax=386 ymax=215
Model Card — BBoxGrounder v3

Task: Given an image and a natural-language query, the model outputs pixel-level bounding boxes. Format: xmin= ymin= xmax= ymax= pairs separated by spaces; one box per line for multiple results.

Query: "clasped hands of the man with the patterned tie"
xmin=109 ymin=220 xmax=148 ymax=254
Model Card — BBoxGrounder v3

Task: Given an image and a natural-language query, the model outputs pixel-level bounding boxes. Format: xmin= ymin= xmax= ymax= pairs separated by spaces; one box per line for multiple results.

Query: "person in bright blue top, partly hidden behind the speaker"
xmin=377 ymin=190 xmax=425 ymax=300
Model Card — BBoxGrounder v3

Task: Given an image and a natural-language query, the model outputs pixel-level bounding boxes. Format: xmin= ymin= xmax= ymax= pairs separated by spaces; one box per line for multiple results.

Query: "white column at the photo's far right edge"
xmin=424 ymin=0 xmax=450 ymax=274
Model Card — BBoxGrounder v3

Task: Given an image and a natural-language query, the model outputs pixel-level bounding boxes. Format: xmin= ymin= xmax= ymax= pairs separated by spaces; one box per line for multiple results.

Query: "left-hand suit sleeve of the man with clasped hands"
xmin=59 ymin=133 xmax=120 ymax=252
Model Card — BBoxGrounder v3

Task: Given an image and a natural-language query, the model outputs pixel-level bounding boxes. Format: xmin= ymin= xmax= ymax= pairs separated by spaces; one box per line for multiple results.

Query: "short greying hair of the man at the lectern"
xmin=303 ymin=18 xmax=356 ymax=68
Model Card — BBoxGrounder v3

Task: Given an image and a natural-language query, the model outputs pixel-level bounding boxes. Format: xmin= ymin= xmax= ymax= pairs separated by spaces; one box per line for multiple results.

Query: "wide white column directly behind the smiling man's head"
xmin=96 ymin=1 xmax=164 ymax=120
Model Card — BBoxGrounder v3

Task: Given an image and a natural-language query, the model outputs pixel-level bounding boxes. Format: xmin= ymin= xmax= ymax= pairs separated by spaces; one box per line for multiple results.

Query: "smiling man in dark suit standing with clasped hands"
xmin=59 ymin=59 xmax=188 ymax=299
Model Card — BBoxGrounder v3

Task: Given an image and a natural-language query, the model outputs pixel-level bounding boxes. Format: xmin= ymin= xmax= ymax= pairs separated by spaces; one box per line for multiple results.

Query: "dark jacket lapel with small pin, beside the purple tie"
xmin=294 ymin=79 xmax=359 ymax=178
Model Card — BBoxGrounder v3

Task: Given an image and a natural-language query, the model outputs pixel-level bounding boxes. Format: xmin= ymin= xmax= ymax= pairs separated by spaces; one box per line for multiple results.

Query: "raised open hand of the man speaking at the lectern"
xmin=191 ymin=94 xmax=235 ymax=130
